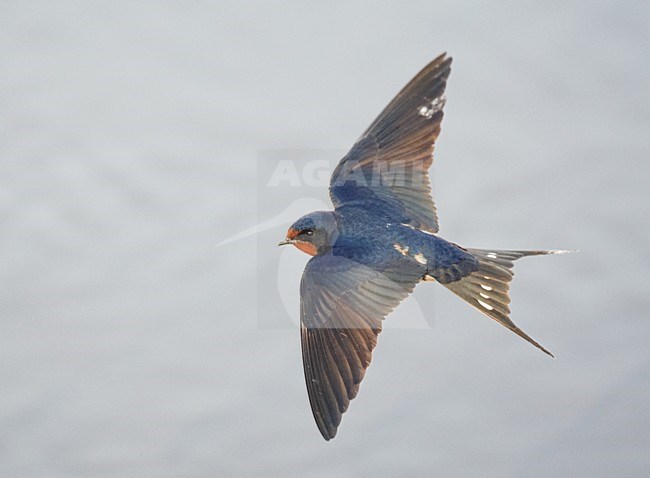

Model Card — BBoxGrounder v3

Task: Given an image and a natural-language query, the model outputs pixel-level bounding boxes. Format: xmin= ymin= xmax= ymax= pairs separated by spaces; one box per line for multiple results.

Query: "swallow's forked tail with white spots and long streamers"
xmin=443 ymin=249 xmax=571 ymax=357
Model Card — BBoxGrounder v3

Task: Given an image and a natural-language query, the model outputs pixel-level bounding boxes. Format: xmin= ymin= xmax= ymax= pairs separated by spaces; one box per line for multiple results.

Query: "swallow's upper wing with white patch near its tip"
xmin=330 ymin=54 xmax=451 ymax=232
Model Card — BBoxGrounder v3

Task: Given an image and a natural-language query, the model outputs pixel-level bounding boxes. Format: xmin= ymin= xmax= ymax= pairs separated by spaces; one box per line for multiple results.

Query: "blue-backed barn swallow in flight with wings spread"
xmin=279 ymin=54 xmax=567 ymax=440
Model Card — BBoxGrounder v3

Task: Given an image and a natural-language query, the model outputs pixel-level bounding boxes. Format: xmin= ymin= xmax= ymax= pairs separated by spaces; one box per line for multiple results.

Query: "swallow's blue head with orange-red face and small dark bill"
xmin=278 ymin=211 xmax=337 ymax=256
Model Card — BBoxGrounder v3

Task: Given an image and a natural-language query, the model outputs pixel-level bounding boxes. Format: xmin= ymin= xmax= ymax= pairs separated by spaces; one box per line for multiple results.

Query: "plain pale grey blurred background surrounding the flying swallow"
xmin=0 ymin=1 xmax=650 ymax=477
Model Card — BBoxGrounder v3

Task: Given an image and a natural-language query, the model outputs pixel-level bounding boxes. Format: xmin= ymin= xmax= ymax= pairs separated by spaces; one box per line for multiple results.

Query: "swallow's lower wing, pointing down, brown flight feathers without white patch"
xmin=300 ymin=253 xmax=422 ymax=440
